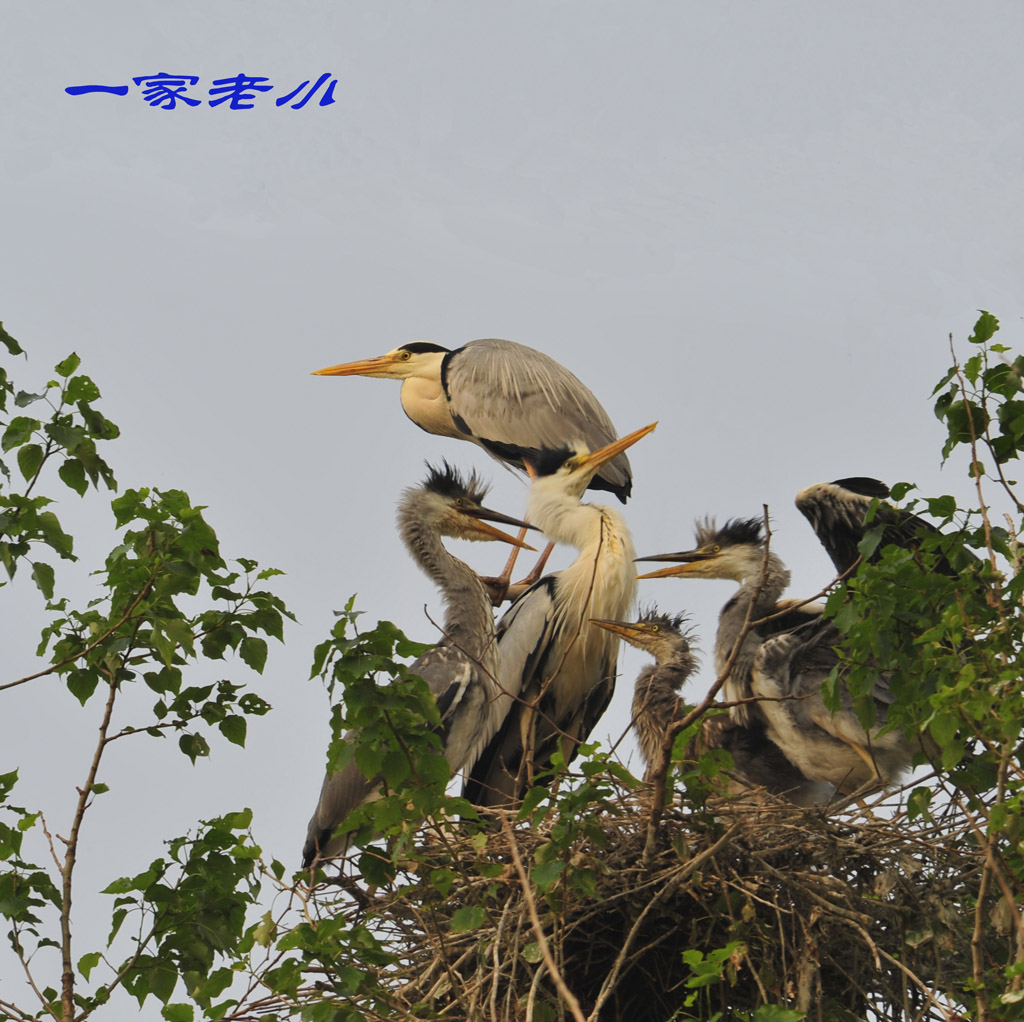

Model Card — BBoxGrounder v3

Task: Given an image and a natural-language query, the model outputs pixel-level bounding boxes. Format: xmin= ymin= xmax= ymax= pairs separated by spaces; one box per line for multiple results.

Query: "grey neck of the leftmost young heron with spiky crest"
xmin=400 ymin=515 xmax=497 ymax=673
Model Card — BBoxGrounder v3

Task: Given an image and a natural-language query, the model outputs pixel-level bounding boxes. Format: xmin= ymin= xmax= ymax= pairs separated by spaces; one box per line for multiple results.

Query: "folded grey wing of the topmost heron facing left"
xmin=441 ymin=339 xmax=632 ymax=496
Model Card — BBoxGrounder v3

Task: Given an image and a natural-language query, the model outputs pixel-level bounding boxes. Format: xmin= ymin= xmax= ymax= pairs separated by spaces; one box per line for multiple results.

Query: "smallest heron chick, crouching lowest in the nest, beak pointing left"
xmin=593 ymin=607 xmax=834 ymax=806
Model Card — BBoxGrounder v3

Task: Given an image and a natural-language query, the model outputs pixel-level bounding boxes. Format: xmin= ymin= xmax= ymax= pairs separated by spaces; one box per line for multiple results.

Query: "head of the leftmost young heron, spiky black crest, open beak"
xmin=398 ymin=462 xmax=536 ymax=550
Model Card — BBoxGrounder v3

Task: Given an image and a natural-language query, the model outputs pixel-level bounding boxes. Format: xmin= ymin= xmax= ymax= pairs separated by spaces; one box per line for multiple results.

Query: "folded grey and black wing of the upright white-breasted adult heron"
xmin=463 ymin=576 xmax=555 ymax=806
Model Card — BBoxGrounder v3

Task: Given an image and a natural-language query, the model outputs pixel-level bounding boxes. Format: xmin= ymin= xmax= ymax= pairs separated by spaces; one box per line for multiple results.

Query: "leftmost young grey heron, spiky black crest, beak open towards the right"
xmin=302 ymin=463 xmax=532 ymax=868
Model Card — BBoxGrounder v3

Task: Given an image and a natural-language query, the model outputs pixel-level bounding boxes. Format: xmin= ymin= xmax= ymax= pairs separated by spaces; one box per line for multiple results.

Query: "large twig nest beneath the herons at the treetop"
xmin=288 ymin=785 xmax=999 ymax=1022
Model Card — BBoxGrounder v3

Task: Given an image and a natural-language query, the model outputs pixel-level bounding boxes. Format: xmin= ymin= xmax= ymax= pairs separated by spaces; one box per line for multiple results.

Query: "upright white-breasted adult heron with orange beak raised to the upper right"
xmin=463 ymin=424 xmax=654 ymax=806
